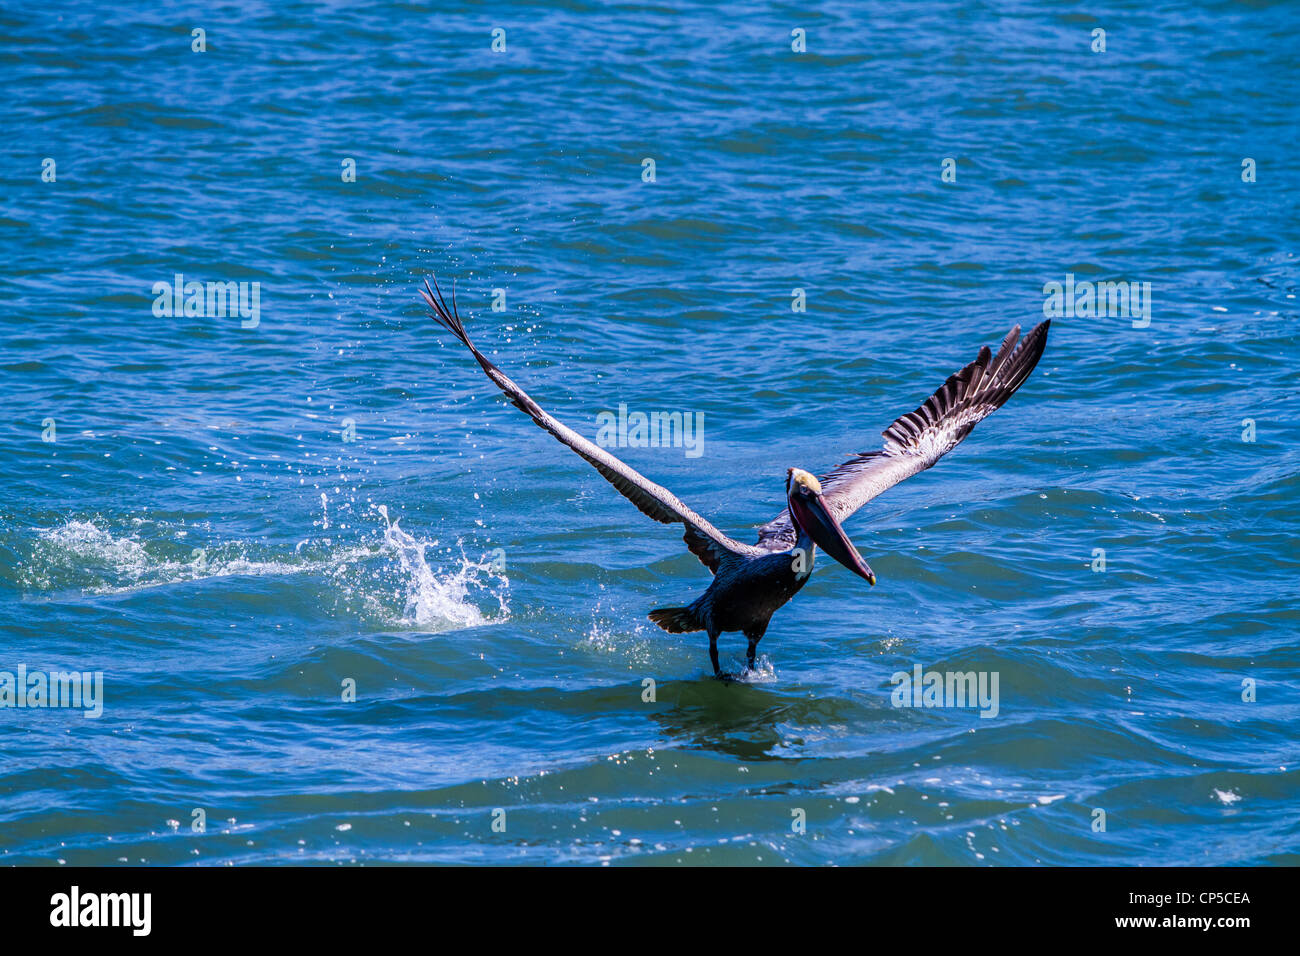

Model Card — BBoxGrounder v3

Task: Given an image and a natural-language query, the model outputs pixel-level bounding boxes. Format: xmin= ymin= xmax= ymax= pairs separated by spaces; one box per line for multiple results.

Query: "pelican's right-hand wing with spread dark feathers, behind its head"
xmin=758 ymin=321 xmax=1052 ymax=549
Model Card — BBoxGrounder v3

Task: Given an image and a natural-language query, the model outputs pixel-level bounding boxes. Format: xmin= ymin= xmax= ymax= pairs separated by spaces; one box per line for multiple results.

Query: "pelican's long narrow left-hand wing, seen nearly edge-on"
xmin=420 ymin=280 xmax=761 ymax=572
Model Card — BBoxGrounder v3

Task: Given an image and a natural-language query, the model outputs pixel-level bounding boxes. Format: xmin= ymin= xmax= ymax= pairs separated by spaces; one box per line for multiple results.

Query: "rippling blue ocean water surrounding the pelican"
xmin=0 ymin=0 xmax=1300 ymax=865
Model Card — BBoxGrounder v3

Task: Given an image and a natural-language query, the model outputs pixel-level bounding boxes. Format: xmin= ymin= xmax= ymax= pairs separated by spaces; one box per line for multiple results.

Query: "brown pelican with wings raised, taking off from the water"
xmin=420 ymin=280 xmax=1050 ymax=678
